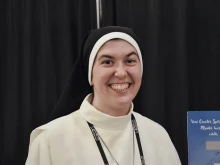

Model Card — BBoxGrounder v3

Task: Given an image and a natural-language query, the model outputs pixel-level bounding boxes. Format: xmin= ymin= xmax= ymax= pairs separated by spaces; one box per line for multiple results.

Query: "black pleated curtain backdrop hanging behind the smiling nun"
xmin=0 ymin=0 xmax=220 ymax=165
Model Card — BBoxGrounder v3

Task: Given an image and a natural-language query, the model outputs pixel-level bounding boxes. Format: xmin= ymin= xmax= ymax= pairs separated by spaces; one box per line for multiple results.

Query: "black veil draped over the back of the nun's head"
xmin=49 ymin=26 xmax=139 ymax=121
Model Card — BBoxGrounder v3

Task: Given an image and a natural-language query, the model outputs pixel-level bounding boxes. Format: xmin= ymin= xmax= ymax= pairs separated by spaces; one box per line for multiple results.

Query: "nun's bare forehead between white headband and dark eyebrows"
xmin=97 ymin=39 xmax=137 ymax=56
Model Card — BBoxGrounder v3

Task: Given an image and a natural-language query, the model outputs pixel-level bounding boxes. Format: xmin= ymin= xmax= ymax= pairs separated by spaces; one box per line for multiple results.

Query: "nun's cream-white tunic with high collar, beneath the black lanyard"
xmin=26 ymin=95 xmax=181 ymax=165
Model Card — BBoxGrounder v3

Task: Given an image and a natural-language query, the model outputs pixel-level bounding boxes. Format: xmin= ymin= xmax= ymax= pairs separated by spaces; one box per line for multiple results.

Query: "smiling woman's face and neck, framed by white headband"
xmin=92 ymin=39 xmax=142 ymax=114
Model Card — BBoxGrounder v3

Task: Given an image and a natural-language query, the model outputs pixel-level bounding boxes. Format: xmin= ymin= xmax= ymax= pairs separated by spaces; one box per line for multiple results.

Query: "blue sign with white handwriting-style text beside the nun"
xmin=187 ymin=111 xmax=220 ymax=165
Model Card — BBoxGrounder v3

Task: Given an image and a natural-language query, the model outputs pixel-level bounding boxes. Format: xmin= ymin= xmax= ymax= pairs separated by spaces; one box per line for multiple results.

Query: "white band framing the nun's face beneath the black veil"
xmin=88 ymin=32 xmax=143 ymax=85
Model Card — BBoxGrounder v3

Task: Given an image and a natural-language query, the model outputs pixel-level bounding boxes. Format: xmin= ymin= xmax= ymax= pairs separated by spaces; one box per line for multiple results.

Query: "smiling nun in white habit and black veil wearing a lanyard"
xmin=26 ymin=26 xmax=181 ymax=165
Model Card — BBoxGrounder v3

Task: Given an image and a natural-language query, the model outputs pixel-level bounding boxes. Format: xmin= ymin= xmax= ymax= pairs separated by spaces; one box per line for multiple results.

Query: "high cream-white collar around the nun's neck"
xmin=79 ymin=94 xmax=133 ymax=130
